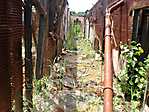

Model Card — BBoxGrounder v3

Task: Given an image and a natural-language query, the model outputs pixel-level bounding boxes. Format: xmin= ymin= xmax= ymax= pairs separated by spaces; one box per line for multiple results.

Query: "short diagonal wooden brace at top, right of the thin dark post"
xmin=32 ymin=0 xmax=46 ymax=15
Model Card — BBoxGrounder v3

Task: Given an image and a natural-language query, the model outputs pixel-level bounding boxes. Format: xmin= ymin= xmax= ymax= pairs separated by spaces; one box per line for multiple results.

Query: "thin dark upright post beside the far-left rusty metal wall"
xmin=24 ymin=0 xmax=33 ymax=112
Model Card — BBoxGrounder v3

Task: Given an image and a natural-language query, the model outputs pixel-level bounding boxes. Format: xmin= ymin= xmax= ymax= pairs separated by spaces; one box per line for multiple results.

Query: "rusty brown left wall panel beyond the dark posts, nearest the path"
xmin=43 ymin=0 xmax=67 ymax=74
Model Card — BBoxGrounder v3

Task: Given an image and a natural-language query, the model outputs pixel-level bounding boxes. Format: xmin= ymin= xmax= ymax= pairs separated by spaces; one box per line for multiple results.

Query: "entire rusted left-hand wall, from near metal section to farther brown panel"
xmin=0 ymin=0 xmax=68 ymax=112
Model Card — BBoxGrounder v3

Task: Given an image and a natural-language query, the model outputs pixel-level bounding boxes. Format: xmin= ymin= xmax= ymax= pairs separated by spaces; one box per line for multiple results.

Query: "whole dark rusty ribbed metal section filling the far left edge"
xmin=0 ymin=0 xmax=22 ymax=112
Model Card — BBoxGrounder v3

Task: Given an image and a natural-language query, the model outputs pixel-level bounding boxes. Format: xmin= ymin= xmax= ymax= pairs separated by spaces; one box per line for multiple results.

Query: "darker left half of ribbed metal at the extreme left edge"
xmin=0 ymin=0 xmax=11 ymax=112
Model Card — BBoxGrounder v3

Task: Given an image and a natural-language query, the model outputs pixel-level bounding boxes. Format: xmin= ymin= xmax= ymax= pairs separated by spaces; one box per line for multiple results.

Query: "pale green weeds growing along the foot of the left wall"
xmin=32 ymin=61 xmax=67 ymax=112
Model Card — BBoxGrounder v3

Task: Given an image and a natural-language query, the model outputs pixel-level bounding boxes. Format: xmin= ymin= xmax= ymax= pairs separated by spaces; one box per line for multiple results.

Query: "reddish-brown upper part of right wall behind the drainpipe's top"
xmin=89 ymin=0 xmax=149 ymax=46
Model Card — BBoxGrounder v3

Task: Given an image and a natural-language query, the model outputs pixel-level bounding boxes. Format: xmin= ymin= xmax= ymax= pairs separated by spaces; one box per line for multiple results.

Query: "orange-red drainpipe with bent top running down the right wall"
xmin=104 ymin=0 xmax=124 ymax=112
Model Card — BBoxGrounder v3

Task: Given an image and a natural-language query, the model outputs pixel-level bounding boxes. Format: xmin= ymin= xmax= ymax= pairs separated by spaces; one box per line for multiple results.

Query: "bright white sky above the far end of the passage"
xmin=68 ymin=0 xmax=98 ymax=12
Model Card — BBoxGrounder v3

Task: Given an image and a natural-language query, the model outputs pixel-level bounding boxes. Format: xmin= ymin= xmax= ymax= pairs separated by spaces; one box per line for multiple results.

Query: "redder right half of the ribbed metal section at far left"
xmin=8 ymin=0 xmax=23 ymax=112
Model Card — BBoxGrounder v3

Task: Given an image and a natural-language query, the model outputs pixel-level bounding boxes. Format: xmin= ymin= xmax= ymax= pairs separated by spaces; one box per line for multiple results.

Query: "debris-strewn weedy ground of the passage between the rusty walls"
xmin=33 ymin=37 xmax=103 ymax=112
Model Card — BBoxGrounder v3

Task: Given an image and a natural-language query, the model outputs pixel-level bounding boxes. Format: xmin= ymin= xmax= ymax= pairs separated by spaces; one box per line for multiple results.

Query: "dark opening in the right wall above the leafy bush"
xmin=132 ymin=8 xmax=149 ymax=57
